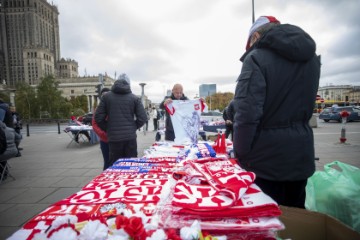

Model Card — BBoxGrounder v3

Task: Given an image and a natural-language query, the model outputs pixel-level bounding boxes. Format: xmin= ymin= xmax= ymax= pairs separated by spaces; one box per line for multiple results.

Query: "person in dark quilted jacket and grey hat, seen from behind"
xmin=95 ymin=74 xmax=147 ymax=166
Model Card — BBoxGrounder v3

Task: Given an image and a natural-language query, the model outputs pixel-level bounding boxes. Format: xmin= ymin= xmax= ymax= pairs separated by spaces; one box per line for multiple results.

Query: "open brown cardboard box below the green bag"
xmin=278 ymin=206 xmax=360 ymax=240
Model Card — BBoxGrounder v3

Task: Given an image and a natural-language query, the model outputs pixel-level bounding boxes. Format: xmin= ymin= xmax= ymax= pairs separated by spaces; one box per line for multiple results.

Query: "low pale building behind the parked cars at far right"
xmin=318 ymin=85 xmax=360 ymax=105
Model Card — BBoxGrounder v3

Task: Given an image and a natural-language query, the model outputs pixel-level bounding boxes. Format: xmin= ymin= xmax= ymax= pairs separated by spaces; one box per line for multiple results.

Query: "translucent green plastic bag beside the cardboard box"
xmin=305 ymin=161 xmax=360 ymax=232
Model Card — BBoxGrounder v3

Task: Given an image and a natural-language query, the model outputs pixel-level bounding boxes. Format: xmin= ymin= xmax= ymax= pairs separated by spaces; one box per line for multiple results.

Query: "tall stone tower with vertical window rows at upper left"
xmin=0 ymin=0 xmax=60 ymax=86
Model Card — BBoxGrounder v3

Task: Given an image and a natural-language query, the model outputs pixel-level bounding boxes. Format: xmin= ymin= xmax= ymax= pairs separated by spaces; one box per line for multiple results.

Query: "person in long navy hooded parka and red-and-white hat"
xmin=234 ymin=16 xmax=321 ymax=208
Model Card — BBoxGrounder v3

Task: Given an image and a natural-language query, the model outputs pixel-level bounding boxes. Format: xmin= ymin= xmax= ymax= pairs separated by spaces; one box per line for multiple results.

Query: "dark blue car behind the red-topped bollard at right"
xmin=319 ymin=106 xmax=360 ymax=122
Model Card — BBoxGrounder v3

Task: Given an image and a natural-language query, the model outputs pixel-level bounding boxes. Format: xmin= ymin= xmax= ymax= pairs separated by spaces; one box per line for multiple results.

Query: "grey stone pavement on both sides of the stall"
xmin=0 ymin=118 xmax=360 ymax=239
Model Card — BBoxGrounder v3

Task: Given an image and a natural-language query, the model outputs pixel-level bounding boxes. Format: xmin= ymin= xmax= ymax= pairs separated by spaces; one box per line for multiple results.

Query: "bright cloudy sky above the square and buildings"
xmin=48 ymin=0 xmax=360 ymax=102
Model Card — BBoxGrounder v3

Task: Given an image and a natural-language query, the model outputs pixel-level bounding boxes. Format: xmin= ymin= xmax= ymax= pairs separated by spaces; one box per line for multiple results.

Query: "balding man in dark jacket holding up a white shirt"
xmin=160 ymin=83 xmax=189 ymax=141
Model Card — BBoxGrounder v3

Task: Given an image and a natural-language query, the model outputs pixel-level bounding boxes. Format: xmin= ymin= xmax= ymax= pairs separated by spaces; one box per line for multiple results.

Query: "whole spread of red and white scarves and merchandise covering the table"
xmin=10 ymin=142 xmax=284 ymax=240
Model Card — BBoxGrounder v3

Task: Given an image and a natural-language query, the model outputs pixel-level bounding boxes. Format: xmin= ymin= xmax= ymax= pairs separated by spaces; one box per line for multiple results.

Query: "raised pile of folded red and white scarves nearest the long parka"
xmin=153 ymin=143 xmax=284 ymax=239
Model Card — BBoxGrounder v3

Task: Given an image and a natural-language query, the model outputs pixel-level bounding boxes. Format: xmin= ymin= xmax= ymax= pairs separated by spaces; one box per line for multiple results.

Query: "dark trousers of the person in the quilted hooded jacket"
xmin=109 ymin=138 xmax=137 ymax=166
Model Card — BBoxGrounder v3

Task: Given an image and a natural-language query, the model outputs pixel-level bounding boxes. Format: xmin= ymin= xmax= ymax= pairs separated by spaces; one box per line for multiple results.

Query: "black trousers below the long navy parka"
xmin=255 ymin=178 xmax=307 ymax=208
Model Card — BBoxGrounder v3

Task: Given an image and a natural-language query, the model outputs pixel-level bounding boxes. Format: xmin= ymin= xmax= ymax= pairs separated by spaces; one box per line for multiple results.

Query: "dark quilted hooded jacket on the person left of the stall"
xmin=95 ymin=80 xmax=147 ymax=142
